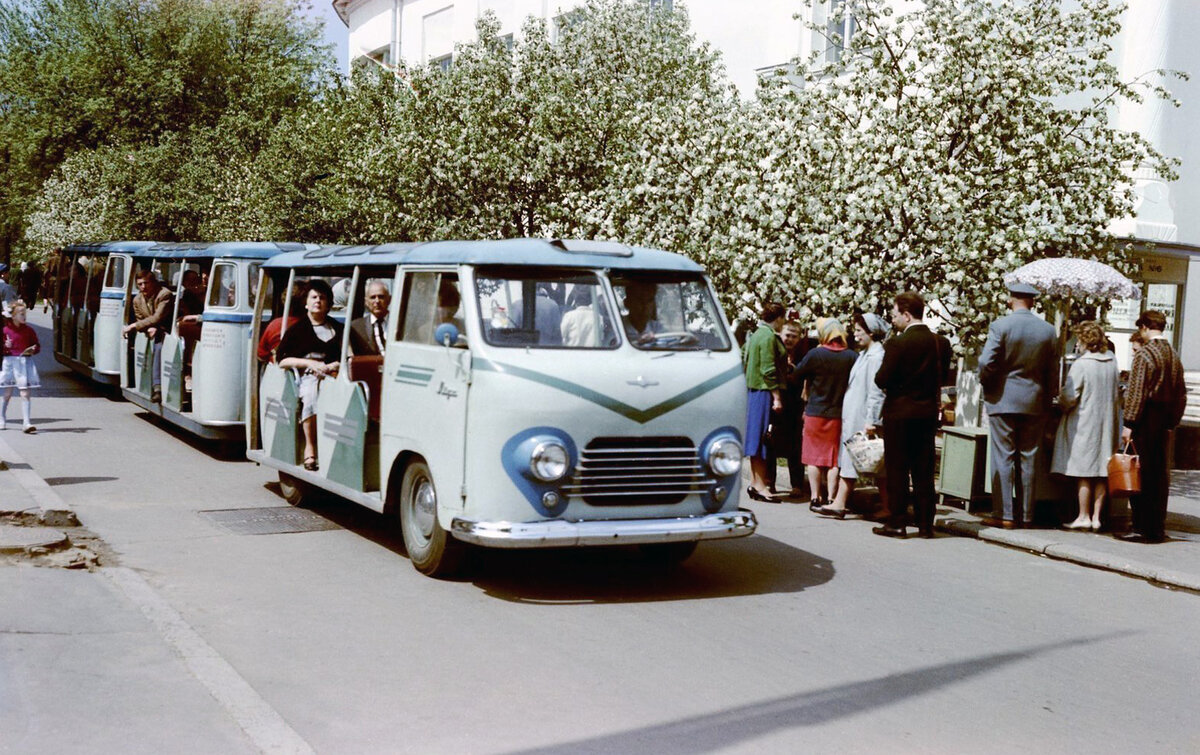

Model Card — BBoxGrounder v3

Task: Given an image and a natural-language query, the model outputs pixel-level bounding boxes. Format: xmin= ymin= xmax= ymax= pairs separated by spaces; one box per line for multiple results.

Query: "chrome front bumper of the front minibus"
xmin=450 ymin=509 xmax=758 ymax=547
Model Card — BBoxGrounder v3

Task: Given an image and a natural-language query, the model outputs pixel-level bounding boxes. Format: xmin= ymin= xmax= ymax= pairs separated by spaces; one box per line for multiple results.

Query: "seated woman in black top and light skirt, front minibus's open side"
xmin=276 ymin=280 xmax=342 ymax=472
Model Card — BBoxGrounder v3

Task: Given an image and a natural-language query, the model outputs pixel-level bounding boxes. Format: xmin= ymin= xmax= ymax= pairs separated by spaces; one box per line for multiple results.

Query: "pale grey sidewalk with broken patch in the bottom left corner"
xmin=0 ymin=438 xmax=312 ymax=754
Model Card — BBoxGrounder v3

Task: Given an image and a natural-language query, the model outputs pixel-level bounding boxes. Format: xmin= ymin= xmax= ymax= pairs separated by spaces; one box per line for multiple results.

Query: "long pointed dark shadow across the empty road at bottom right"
xmin=504 ymin=633 xmax=1132 ymax=755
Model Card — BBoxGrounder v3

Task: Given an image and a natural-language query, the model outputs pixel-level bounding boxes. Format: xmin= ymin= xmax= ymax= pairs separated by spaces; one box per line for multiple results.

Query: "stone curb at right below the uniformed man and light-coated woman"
xmin=935 ymin=517 xmax=1200 ymax=592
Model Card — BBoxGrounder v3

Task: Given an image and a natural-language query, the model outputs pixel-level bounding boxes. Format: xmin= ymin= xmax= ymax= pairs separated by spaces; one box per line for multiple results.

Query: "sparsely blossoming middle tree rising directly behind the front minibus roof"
xmin=240 ymin=0 xmax=732 ymax=241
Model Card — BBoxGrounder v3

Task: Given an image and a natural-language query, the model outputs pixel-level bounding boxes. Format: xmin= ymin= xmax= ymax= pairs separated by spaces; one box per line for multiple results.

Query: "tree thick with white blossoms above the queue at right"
xmin=594 ymin=0 xmax=1174 ymax=346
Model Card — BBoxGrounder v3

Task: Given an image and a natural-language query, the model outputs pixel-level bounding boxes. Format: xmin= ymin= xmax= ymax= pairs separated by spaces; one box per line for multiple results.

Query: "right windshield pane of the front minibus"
xmin=611 ymin=271 xmax=730 ymax=352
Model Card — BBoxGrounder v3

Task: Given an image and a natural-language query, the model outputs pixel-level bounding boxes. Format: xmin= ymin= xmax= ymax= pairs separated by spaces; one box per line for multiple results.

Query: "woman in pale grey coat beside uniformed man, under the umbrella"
xmin=1050 ymin=320 xmax=1121 ymax=531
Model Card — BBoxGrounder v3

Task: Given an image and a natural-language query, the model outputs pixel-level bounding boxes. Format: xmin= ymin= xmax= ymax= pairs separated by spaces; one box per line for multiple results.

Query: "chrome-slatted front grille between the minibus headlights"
xmin=563 ymin=437 xmax=714 ymax=507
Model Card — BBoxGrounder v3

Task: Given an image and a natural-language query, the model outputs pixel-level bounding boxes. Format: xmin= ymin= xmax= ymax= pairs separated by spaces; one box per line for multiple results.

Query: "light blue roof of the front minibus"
xmin=264 ymin=239 xmax=703 ymax=272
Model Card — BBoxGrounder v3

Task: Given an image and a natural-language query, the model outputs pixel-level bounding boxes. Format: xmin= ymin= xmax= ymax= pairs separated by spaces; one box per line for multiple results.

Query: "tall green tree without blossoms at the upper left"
xmin=0 ymin=0 xmax=332 ymax=251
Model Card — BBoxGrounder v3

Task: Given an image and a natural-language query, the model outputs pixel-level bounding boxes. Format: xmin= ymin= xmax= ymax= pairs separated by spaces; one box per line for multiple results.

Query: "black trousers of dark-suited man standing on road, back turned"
xmin=883 ymin=418 xmax=937 ymax=532
